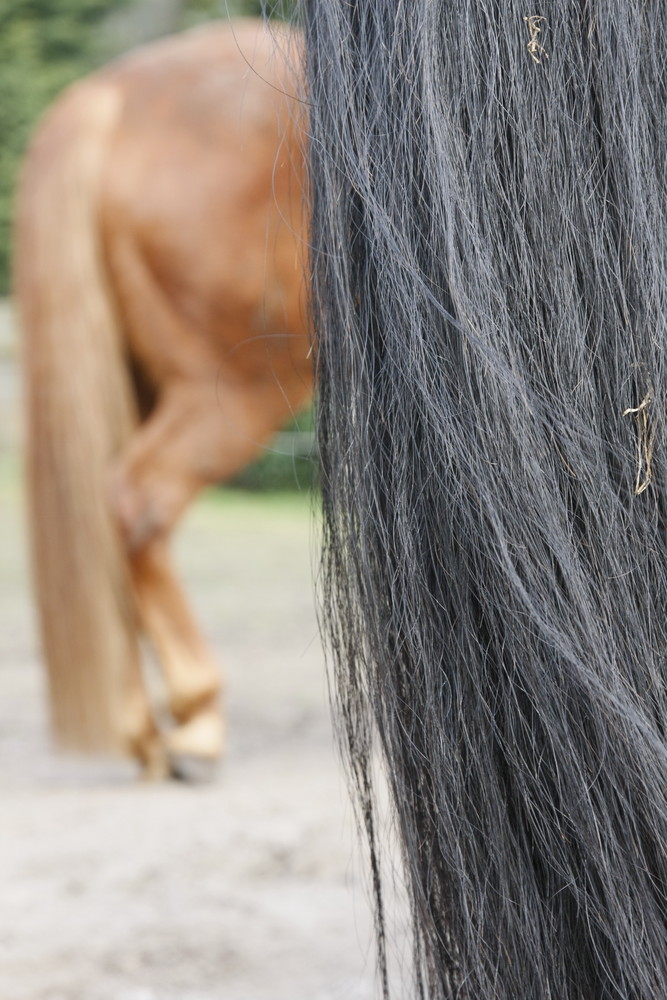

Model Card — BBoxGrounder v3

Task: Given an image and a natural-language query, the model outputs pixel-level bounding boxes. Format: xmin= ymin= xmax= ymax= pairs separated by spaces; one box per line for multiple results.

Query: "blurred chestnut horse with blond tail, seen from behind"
xmin=15 ymin=21 xmax=312 ymax=776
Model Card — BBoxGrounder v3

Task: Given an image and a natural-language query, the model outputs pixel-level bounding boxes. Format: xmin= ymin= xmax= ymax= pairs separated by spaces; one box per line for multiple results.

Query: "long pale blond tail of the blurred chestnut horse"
xmin=15 ymin=84 xmax=137 ymax=750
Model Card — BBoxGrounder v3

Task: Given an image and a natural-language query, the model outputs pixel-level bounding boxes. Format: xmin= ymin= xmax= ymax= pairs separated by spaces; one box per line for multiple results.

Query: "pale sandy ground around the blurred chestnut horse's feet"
xmin=0 ymin=340 xmax=376 ymax=1000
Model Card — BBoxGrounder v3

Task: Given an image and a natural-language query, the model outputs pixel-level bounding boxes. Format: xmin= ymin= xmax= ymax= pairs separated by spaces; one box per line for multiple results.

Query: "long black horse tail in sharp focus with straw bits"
xmin=303 ymin=0 xmax=667 ymax=1000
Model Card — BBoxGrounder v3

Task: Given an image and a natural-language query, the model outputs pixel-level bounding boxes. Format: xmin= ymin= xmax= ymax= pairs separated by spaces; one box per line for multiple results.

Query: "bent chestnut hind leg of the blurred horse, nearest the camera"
xmin=111 ymin=380 xmax=275 ymax=770
